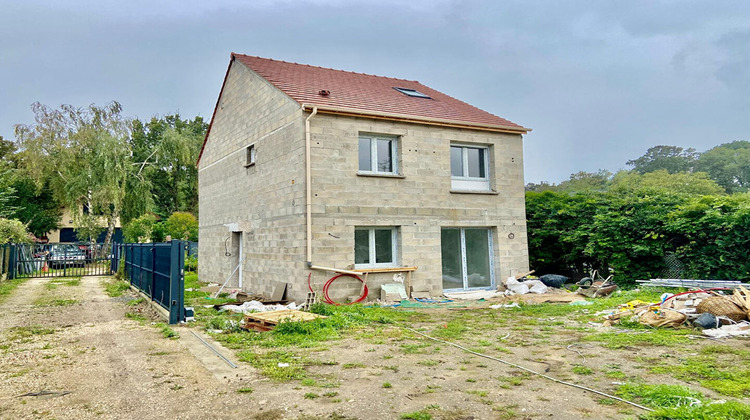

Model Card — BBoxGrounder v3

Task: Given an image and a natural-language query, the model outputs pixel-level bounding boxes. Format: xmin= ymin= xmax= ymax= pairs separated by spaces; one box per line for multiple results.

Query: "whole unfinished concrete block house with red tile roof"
xmin=198 ymin=53 xmax=529 ymax=301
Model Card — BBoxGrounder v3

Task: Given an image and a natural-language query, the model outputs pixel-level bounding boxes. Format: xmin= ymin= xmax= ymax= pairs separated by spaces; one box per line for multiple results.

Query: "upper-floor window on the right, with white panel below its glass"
xmin=451 ymin=145 xmax=490 ymax=191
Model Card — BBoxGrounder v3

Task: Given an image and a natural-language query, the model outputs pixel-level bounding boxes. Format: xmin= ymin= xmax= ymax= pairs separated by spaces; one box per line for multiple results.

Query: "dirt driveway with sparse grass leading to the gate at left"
xmin=0 ymin=277 xmax=268 ymax=419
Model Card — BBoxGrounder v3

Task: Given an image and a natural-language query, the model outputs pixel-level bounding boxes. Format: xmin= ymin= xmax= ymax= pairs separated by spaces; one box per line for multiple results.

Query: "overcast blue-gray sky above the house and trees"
xmin=0 ymin=0 xmax=750 ymax=182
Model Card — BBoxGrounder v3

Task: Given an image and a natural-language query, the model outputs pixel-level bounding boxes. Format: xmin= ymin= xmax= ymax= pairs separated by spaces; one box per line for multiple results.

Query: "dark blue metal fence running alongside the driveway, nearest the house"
xmin=112 ymin=240 xmax=189 ymax=324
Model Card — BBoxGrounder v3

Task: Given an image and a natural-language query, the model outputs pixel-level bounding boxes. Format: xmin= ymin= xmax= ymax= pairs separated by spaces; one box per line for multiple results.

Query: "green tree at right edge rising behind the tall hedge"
xmin=696 ymin=140 xmax=750 ymax=194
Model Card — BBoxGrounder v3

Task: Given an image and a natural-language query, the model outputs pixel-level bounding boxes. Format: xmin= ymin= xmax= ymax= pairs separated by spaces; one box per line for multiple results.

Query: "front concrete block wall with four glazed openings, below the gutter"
xmin=311 ymin=114 xmax=529 ymax=298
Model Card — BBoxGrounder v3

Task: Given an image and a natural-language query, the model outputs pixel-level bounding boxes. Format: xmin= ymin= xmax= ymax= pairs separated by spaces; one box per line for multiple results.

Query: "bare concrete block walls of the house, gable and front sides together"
xmin=199 ymin=62 xmax=528 ymax=300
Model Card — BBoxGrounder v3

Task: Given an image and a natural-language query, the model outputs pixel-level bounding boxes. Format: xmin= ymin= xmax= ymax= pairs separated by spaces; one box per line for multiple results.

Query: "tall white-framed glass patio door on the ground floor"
xmin=440 ymin=228 xmax=495 ymax=290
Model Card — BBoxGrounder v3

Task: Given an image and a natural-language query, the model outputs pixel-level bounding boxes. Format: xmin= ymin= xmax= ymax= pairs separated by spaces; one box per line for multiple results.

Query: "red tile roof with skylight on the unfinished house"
xmin=232 ymin=53 xmax=528 ymax=132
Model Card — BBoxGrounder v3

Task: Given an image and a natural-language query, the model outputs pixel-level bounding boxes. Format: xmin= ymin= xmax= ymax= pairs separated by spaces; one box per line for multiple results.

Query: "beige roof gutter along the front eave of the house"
xmin=302 ymin=104 xmax=531 ymax=134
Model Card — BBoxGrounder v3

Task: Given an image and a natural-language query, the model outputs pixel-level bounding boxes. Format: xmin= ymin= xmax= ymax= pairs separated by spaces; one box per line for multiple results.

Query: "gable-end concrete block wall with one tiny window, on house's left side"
xmin=198 ymin=62 xmax=307 ymax=298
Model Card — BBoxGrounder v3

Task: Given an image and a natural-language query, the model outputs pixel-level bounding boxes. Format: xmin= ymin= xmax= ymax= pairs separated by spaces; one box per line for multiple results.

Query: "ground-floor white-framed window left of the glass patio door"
xmin=354 ymin=227 xmax=396 ymax=268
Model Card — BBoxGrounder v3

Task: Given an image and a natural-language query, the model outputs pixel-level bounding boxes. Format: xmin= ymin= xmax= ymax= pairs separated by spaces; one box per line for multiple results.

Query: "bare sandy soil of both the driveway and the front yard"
xmin=0 ymin=277 xmax=748 ymax=420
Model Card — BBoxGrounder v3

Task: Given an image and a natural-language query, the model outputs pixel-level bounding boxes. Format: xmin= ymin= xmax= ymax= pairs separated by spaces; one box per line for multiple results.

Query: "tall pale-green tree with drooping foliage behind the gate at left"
xmin=16 ymin=102 xmax=148 ymax=246
